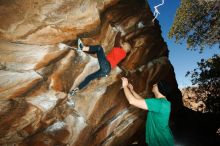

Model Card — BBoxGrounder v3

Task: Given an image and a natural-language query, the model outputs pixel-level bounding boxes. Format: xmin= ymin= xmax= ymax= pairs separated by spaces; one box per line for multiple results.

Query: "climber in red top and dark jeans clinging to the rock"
xmin=69 ymin=33 xmax=131 ymax=96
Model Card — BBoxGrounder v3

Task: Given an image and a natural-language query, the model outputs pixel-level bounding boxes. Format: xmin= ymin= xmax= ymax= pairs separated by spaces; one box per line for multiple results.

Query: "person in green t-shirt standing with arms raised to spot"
xmin=122 ymin=77 xmax=174 ymax=146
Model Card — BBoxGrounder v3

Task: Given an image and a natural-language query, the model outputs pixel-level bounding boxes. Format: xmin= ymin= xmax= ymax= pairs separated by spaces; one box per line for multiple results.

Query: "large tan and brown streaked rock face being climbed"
xmin=0 ymin=0 xmax=180 ymax=146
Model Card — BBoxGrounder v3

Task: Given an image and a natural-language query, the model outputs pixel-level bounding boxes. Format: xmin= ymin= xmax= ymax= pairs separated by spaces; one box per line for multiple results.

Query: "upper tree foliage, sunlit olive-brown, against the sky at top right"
xmin=169 ymin=0 xmax=220 ymax=51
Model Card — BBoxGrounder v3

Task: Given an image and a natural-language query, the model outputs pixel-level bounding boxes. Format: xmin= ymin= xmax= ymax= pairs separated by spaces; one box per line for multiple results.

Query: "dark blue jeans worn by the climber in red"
xmin=78 ymin=45 xmax=111 ymax=89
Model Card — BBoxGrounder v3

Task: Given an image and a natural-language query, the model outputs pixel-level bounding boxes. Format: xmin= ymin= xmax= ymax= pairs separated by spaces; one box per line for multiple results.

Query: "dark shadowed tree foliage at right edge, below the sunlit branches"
xmin=186 ymin=55 xmax=220 ymax=113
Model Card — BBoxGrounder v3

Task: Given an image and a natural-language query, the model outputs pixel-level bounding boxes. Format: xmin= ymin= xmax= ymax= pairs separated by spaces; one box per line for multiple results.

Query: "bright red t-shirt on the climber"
xmin=106 ymin=47 xmax=126 ymax=68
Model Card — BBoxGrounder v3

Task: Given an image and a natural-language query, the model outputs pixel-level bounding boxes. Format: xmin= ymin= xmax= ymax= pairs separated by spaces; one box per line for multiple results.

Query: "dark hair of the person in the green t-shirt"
xmin=157 ymin=80 xmax=172 ymax=97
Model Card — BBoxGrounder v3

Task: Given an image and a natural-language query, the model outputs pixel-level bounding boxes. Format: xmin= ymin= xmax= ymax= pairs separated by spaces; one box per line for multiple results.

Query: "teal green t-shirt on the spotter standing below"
xmin=145 ymin=98 xmax=174 ymax=146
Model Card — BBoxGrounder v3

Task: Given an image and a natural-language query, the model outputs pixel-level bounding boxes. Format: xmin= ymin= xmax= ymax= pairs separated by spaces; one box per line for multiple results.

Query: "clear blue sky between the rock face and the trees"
xmin=148 ymin=0 xmax=220 ymax=88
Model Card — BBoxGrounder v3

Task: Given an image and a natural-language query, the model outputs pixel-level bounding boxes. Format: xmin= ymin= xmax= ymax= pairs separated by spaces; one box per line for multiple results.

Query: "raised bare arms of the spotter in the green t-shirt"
xmin=122 ymin=77 xmax=148 ymax=110
